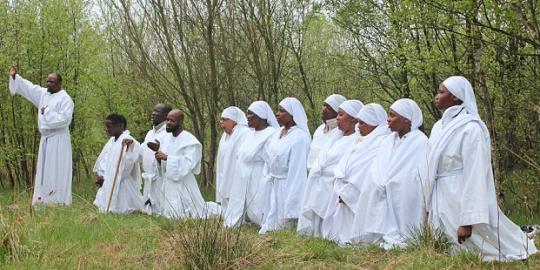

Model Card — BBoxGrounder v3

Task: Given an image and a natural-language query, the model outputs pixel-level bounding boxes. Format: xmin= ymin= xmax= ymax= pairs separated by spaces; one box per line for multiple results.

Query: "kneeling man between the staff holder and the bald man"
xmin=140 ymin=103 xmax=172 ymax=215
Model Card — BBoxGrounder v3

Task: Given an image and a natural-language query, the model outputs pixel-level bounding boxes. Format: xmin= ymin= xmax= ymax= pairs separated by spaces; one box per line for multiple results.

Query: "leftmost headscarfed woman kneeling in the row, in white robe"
xmin=216 ymin=106 xmax=249 ymax=213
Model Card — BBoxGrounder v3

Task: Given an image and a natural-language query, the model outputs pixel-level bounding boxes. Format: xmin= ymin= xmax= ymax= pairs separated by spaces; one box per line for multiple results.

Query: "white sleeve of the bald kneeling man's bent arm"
xmin=165 ymin=145 xmax=202 ymax=181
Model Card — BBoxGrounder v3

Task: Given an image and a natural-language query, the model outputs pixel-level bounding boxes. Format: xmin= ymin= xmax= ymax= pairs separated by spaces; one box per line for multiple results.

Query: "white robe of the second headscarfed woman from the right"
xmin=350 ymin=130 xmax=428 ymax=249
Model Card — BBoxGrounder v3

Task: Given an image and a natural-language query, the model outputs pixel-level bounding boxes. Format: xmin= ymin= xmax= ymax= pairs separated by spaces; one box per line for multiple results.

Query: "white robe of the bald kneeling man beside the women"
xmin=160 ymin=130 xmax=220 ymax=219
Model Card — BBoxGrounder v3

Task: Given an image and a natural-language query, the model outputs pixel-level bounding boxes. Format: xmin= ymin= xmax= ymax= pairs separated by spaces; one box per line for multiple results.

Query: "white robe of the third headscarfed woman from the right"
xmin=321 ymin=125 xmax=390 ymax=244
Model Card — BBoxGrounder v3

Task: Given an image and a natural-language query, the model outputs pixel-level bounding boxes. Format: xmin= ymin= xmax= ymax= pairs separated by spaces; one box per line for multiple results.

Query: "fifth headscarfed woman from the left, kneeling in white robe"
xmin=297 ymin=100 xmax=364 ymax=237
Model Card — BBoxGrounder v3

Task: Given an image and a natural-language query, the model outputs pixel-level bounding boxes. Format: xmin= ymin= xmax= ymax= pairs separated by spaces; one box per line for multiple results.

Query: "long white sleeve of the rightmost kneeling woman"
xmin=456 ymin=125 xmax=493 ymax=226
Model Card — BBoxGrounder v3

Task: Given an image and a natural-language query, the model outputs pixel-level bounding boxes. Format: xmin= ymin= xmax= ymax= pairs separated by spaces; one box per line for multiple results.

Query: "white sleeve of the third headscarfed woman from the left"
xmin=285 ymin=138 xmax=309 ymax=218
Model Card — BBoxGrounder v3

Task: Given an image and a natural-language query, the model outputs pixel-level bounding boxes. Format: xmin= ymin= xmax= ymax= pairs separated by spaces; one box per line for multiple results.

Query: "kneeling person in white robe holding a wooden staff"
xmin=94 ymin=113 xmax=143 ymax=214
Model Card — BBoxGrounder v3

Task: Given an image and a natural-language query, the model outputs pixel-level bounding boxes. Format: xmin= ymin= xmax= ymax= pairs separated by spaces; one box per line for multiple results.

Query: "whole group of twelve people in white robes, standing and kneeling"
xmin=9 ymin=67 xmax=537 ymax=261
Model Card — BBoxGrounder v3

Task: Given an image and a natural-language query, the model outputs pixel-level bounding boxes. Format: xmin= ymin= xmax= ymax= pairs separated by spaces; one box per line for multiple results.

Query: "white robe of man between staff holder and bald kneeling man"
xmin=140 ymin=122 xmax=166 ymax=215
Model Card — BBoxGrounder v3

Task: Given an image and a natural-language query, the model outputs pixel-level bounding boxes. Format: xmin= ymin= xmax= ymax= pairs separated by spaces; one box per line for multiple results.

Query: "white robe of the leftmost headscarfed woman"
xmin=216 ymin=124 xmax=250 ymax=209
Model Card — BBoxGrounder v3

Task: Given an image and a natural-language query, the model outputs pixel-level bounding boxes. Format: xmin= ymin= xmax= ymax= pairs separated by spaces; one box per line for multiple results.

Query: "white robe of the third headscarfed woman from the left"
xmin=259 ymin=126 xmax=311 ymax=234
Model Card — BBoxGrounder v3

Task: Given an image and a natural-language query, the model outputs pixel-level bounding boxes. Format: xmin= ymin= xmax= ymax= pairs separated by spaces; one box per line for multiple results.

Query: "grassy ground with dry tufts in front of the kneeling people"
xmin=0 ymin=181 xmax=540 ymax=269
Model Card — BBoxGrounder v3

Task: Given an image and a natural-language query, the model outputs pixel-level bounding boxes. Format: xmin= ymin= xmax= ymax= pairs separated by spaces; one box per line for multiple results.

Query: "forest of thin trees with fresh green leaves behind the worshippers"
xmin=0 ymin=0 xmax=540 ymax=216
